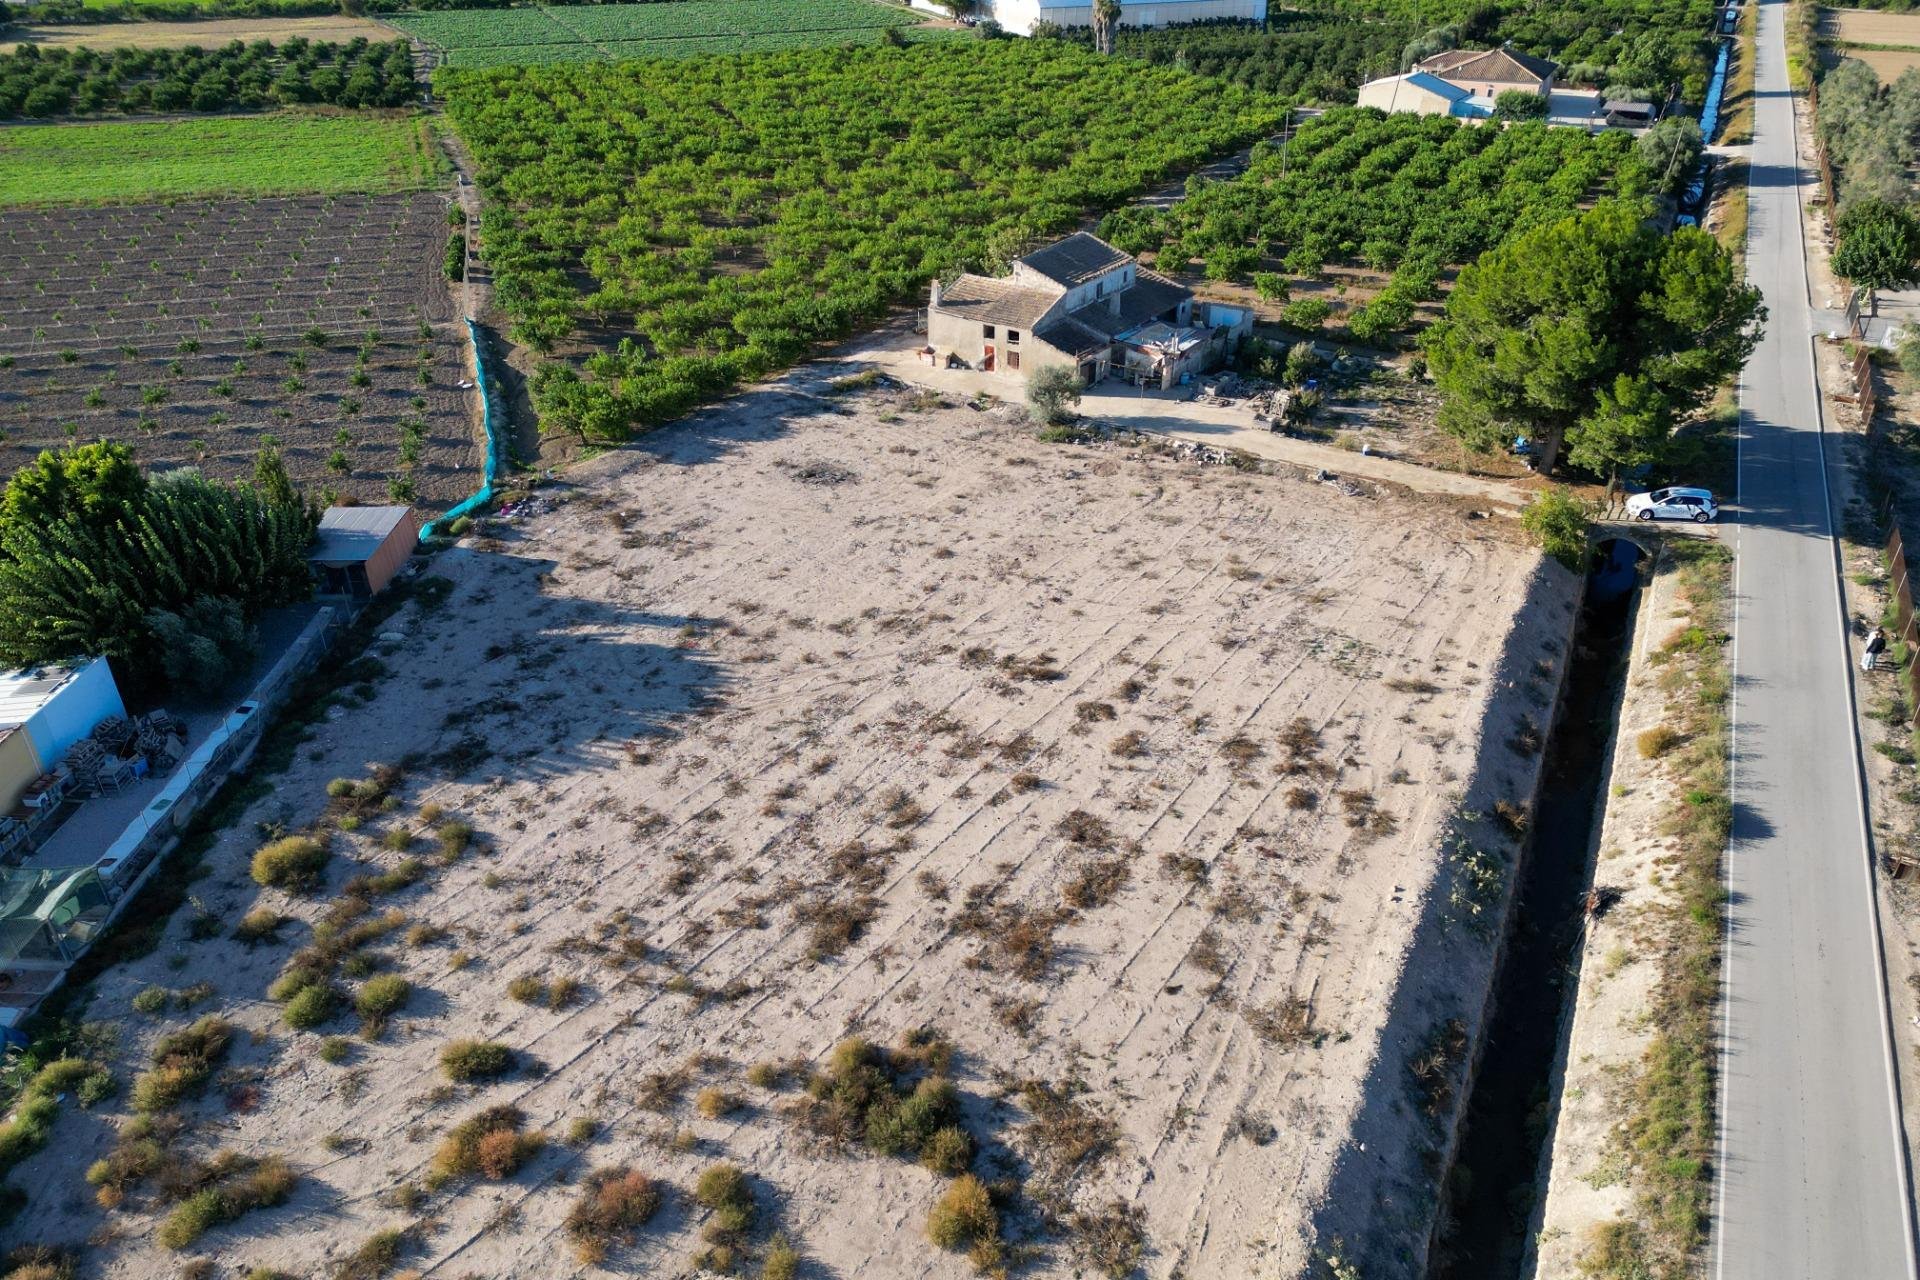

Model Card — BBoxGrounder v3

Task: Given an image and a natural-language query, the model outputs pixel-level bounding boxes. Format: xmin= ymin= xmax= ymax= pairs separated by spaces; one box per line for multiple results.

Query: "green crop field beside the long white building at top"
xmin=388 ymin=0 xmax=936 ymax=67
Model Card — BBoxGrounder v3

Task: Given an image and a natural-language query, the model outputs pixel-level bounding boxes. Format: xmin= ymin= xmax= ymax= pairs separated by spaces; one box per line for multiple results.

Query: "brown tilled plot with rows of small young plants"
xmin=0 ymin=192 xmax=482 ymax=509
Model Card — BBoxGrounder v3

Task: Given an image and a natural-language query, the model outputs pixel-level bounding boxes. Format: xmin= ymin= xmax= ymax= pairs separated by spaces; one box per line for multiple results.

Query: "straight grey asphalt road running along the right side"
xmin=1715 ymin=0 xmax=1914 ymax=1280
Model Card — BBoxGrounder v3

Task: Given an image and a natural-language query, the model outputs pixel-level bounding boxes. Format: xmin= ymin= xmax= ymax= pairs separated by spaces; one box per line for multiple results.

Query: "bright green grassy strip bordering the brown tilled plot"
xmin=0 ymin=115 xmax=445 ymax=207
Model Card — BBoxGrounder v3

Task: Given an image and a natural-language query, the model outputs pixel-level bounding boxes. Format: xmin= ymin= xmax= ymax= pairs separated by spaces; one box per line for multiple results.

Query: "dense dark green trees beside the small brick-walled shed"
xmin=0 ymin=441 xmax=317 ymax=702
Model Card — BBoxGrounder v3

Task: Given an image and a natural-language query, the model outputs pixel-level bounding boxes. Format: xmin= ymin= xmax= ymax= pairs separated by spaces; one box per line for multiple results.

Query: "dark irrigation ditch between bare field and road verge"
xmin=1428 ymin=539 xmax=1642 ymax=1280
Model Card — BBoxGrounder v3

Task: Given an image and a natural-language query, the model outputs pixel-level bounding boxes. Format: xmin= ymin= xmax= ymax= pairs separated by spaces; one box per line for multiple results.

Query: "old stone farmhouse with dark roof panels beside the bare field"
xmin=922 ymin=232 xmax=1254 ymax=388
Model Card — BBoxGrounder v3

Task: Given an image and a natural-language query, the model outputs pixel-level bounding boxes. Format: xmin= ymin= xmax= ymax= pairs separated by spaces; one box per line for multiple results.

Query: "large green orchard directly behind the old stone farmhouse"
xmin=436 ymin=40 xmax=1283 ymax=439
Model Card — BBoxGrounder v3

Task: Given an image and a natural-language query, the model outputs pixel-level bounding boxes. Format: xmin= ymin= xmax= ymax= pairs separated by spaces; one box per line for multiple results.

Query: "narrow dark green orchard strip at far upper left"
xmin=0 ymin=36 xmax=417 ymax=119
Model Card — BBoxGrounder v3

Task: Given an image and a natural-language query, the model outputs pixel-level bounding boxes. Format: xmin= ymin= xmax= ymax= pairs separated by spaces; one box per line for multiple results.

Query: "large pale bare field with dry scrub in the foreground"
xmin=13 ymin=370 xmax=1572 ymax=1278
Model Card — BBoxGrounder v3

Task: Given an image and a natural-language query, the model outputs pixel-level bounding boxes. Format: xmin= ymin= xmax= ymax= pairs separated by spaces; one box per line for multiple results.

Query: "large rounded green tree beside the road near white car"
xmin=1427 ymin=200 xmax=1764 ymax=476
